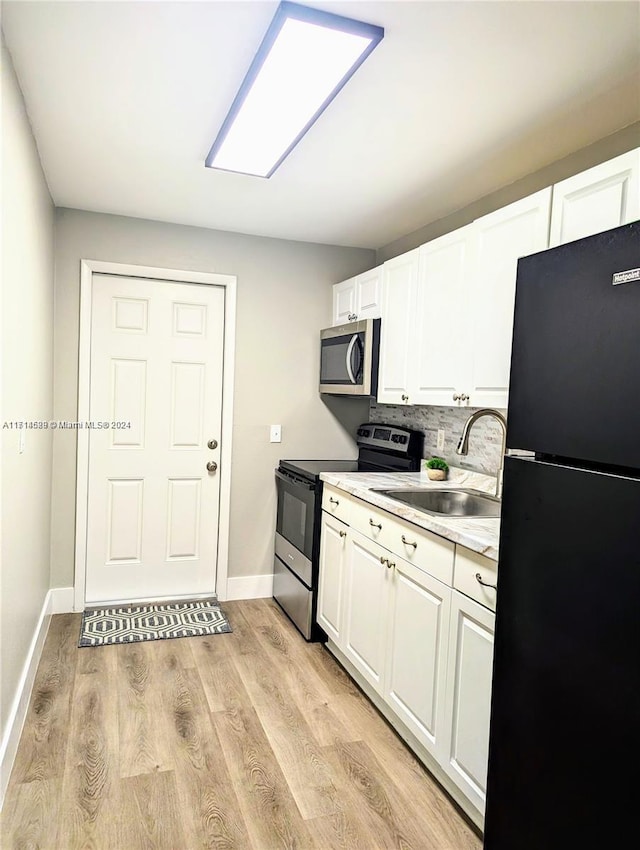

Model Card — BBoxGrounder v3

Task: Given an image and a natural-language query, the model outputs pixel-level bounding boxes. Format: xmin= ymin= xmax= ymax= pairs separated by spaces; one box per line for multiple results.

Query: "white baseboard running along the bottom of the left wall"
xmin=0 ymin=588 xmax=53 ymax=809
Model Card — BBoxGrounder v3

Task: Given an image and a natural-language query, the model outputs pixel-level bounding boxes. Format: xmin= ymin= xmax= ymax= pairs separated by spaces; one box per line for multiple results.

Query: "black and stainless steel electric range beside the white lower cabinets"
xmin=273 ymin=423 xmax=424 ymax=641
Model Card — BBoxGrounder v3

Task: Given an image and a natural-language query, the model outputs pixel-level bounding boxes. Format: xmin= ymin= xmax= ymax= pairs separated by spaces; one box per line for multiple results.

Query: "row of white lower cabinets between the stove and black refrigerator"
xmin=317 ymin=501 xmax=495 ymax=825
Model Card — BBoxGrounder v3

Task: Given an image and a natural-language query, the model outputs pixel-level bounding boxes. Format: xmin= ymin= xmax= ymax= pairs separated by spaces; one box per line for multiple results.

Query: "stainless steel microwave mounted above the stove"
xmin=320 ymin=319 xmax=380 ymax=396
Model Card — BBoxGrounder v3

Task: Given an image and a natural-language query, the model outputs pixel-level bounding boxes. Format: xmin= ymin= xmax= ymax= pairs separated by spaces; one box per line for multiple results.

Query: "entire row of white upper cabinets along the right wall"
xmin=333 ymin=148 xmax=640 ymax=408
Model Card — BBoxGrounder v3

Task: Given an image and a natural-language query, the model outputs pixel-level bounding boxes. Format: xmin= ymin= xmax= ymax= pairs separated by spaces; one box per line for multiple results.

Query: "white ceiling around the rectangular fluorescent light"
xmin=2 ymin=0 xmax=640 ymax=248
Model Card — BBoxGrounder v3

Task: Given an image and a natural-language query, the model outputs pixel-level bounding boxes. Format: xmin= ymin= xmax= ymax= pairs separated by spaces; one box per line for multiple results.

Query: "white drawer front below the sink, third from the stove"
xmin=383 ymin=515 xmax=455 ymax=586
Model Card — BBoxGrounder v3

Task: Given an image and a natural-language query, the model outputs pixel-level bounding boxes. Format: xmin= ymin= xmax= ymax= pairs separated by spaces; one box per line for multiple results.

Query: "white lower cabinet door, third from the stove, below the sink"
xmin=385 ymin=556 xmax=452 ymax=757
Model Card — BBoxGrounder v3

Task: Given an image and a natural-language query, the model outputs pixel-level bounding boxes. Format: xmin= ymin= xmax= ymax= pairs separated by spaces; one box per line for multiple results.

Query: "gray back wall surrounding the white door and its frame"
xmin=52 ymin=209 xmax=375 ymax=587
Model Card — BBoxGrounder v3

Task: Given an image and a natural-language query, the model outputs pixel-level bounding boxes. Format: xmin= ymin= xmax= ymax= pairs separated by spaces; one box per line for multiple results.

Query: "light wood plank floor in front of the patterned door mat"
xmin=2 ymin=600 xmax=482 ymax=850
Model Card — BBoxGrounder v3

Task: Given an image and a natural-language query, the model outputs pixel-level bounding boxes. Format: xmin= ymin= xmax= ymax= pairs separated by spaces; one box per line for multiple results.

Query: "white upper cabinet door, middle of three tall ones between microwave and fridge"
xmin=410 ymin=225 xmax=473 ymax=405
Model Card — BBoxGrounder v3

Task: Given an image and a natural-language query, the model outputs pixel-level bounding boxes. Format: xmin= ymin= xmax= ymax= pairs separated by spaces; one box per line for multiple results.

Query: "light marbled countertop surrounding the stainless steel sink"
xmin=320 ymin=467 xmax=500 ymax=561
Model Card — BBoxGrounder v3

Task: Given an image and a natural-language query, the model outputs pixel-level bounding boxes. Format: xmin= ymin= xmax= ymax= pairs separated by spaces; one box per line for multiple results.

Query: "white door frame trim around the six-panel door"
xmin=73 ymin=259 xmax=237 ymax=611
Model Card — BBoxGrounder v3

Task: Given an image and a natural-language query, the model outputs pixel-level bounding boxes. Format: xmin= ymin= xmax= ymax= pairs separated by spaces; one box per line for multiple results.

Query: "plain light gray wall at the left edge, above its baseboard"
xmin=0 ymin=41 xmax=54 ymax=744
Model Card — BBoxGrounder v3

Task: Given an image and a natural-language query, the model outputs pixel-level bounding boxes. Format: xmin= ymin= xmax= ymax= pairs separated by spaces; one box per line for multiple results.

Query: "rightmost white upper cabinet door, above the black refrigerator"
xmin=549 ymin=148 xmax=640 ymax=248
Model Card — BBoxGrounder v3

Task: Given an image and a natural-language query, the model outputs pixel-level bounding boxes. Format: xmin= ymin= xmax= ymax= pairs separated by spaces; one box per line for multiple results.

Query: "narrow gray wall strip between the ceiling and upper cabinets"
xmin=376 ymin=122 xmax=640 ymax=264
